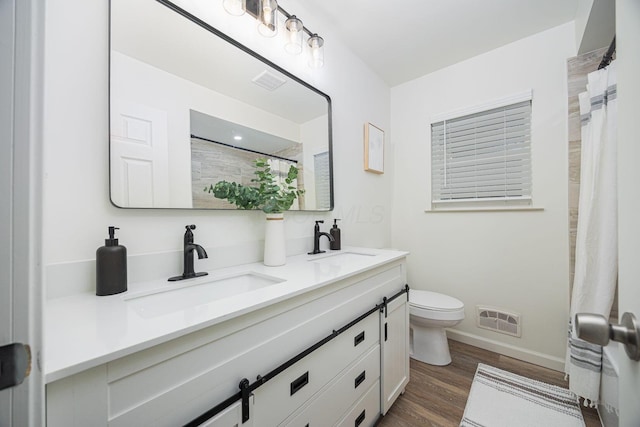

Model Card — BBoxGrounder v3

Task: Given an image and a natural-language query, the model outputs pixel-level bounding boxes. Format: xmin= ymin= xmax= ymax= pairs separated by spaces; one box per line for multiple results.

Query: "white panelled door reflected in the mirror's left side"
xmin=111 ymin=99 xmax=169 ymax=208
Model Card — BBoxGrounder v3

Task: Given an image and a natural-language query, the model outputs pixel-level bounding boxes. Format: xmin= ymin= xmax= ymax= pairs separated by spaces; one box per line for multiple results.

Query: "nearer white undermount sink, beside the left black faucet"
xmin=123 ymin=272 xmax=284 ymax=317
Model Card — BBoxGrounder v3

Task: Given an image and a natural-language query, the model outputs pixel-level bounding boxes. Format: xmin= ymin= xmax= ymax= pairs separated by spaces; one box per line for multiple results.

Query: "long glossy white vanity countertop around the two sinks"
xmin=44 ymin=248 xmax=407 ymax=383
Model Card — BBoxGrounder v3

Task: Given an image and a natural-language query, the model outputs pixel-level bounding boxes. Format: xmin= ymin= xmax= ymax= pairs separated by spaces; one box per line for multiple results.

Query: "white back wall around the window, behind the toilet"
xmin=391 ymin=23 xmax=576 ymax=368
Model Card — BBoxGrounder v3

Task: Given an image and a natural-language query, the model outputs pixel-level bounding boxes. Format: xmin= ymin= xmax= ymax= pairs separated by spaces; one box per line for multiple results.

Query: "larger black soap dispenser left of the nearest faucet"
xmin=96 ymin=226 xmax=127 ymax=296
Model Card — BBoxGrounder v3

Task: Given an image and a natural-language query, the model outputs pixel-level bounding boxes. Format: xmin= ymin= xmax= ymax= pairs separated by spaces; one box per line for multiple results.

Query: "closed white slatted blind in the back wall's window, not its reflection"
xmin=431 ymin=99 xmax=531 ymax=204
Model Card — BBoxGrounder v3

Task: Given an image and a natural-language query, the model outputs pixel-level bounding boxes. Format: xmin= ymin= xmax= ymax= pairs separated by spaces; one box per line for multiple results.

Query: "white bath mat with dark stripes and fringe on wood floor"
xmin=460 ymin=363 xmax=585 ymax=427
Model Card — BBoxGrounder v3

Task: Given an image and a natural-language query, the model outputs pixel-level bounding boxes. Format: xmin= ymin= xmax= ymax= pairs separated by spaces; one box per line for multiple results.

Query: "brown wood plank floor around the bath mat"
xmin=377 ymin=341 xmax=601 ymax=427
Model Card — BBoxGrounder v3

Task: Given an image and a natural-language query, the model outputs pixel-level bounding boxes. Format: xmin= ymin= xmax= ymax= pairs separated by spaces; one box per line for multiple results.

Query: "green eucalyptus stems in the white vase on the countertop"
xmin=204 ymin=158 xmax=304 ymax=213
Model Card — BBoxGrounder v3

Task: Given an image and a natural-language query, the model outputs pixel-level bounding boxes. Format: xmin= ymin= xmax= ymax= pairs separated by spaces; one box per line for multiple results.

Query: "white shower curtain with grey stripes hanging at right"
xmin=565 ymin=61 xmax=618 ymax=406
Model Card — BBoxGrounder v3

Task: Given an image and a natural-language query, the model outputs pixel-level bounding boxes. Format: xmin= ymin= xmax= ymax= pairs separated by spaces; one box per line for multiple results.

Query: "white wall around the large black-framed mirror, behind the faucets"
xmin=43 ymin=0 xmax=392 ymax=294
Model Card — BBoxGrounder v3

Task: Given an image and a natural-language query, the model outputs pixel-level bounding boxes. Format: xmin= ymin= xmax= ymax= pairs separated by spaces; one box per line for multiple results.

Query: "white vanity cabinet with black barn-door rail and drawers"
xmin=46 ymin=258 xmax=409 ymax=427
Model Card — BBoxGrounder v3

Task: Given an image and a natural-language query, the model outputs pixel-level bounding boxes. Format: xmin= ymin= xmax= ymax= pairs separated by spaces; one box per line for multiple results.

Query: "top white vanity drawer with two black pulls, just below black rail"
xmin=254 ymin=312 xmax=380 ymax=427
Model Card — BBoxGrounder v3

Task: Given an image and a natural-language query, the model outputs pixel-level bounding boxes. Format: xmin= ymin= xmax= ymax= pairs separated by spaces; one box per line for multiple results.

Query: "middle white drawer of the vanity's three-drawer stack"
xmin=283 ymin=345 xmax=380 ymax=427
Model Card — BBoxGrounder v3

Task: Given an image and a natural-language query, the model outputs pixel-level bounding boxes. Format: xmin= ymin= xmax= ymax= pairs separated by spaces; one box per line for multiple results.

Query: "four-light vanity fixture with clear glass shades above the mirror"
xmin=223 ymin=0 xmax=324 ymax=68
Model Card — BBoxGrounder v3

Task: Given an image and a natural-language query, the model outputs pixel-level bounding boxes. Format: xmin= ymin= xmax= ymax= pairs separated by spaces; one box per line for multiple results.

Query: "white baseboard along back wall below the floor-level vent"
xmin=447 ymin=329 xmax=564 ymax=372
